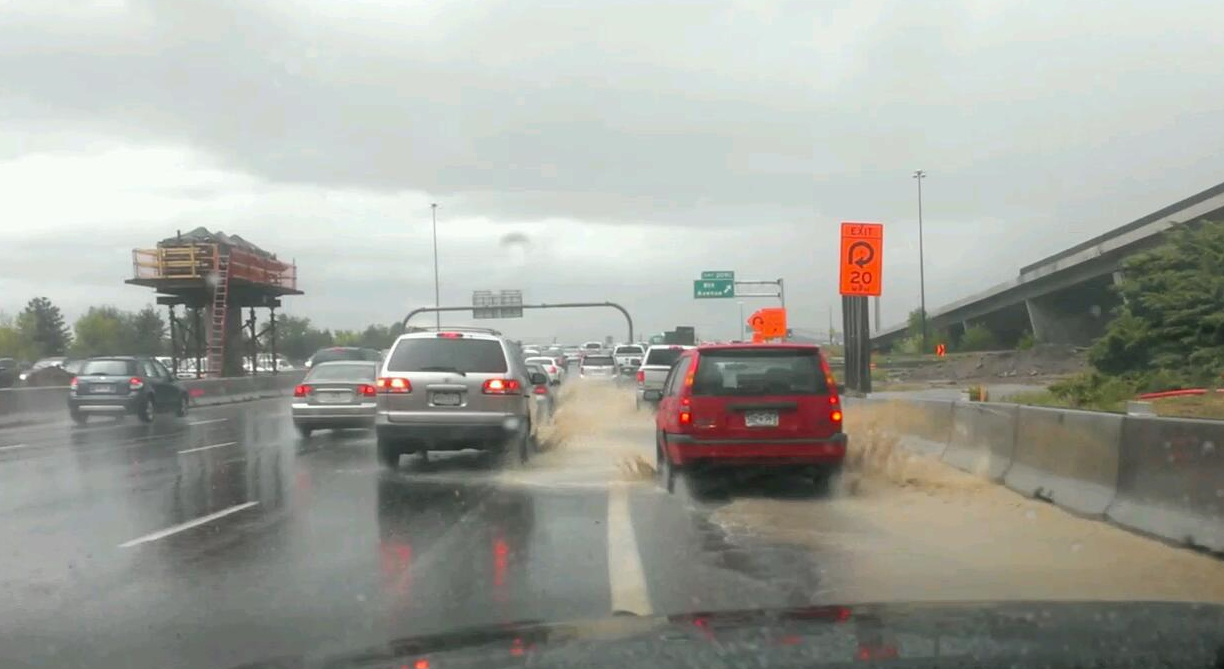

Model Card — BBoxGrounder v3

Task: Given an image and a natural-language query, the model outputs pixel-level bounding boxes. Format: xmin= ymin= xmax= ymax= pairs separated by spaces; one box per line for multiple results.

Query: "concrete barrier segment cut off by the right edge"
xmin=1105 ymin=416 xmax=1224 ymax=552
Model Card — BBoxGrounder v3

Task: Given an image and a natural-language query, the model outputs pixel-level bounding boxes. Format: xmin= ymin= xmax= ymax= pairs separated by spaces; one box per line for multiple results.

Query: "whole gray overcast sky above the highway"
xmin=0 ymin=0 xmax=1224 ymax=340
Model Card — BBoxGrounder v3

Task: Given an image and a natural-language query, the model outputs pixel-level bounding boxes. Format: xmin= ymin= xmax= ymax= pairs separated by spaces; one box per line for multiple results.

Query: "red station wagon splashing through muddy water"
xmin=646 ymin=344 xmax=847 ymax=492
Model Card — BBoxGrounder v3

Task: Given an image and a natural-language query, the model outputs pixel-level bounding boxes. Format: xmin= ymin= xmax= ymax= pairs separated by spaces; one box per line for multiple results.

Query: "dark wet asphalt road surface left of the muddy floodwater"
xmin=0 ymin=388 xmax=819 ymax=667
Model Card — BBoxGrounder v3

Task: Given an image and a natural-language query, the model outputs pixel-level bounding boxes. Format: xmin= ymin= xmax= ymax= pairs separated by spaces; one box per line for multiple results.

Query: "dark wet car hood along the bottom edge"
xmin=225 ymin=602 xmax=1224 ymax=669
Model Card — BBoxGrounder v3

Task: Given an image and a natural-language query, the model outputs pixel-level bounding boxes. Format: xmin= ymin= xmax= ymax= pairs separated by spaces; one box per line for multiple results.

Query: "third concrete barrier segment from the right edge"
xmin=940 ymin=402 xmax=1018 ymax=481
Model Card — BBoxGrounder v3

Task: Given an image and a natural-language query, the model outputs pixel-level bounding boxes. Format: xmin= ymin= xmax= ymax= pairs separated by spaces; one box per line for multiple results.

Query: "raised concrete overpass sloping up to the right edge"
xmin=873 ymin=183 xmax=1224 ymax=349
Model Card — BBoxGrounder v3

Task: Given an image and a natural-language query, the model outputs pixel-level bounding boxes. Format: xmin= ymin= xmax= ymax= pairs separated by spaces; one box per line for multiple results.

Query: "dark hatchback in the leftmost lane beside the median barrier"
xmin=69 ymin=356 xmax=191 ymax=423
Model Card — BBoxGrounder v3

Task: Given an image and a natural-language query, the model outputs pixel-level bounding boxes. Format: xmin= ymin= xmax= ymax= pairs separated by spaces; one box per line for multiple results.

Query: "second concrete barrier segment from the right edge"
xmin=1004 ymin=406 xmax=1122 ymax=516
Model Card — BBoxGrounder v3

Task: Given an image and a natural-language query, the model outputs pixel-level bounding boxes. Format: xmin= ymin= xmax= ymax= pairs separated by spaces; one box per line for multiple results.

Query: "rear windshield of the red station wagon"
xmin=693 ymin=349 xmax=829 ymax=396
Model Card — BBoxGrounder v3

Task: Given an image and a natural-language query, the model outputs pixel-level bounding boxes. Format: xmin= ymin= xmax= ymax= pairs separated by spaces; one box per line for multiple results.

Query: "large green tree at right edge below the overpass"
xmin=1088 ymin=223 xmax=1224 ymax=386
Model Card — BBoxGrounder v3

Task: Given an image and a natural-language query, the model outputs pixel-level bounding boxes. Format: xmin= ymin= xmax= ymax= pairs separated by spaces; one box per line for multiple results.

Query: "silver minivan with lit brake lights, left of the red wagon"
xmin=375 ymin=328 xmax=548 ymax=468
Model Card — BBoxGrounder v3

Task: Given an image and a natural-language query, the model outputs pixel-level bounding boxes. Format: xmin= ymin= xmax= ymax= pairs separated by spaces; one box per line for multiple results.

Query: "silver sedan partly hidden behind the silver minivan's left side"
xmin=291 ymin=361 xmax=378 ymax=437
